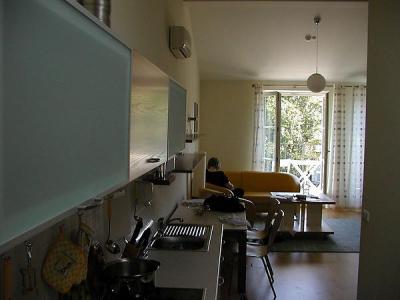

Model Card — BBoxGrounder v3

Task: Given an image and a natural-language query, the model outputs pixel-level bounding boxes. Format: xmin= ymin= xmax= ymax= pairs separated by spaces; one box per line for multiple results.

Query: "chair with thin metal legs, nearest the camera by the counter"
xmin=247 ymin=210 xmax=284 ymax=299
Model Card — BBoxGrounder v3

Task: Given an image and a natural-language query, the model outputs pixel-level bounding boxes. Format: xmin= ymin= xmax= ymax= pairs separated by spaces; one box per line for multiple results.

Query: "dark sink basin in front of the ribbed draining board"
xmin=152 ymin=236 xmax=206 ymax=250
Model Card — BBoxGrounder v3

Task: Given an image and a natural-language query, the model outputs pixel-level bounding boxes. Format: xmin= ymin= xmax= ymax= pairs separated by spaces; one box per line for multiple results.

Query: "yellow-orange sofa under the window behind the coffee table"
xmin=225 ymin=171 xmax=300 ymax=212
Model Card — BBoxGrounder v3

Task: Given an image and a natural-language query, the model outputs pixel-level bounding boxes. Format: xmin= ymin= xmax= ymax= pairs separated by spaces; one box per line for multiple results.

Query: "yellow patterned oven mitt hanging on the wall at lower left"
xmin=42 ymin=232 xmax=86 ymax=294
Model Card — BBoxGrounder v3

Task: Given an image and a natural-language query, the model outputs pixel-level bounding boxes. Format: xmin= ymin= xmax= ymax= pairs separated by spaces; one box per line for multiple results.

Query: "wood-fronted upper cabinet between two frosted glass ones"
xmin=129 ymin=51 xmax=169 ymax=180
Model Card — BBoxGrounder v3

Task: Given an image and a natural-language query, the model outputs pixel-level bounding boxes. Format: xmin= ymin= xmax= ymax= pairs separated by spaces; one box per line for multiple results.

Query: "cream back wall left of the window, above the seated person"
xmin=200 ymin=80 xmax=254 ymax=171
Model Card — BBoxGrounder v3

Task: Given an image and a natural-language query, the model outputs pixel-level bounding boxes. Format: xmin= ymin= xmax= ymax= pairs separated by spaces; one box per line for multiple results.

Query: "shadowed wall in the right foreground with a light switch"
xmin=358 ymin=0 xmax=400 ymax=300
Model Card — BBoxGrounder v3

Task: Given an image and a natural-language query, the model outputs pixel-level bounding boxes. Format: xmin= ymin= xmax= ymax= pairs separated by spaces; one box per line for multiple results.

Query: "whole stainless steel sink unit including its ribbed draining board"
xmin=150 ymin=224 xmax=212 ymax=251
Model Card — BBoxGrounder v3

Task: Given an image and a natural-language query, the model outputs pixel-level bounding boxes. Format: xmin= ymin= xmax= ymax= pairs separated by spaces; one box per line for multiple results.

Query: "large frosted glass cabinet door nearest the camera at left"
xmin=0 ymin=0 xmax=131 ymax=246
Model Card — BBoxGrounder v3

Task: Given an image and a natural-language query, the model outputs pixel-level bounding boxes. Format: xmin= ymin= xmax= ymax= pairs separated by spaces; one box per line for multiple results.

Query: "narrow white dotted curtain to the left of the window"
xmin=252 ymin=84 xmax=265 ymax=171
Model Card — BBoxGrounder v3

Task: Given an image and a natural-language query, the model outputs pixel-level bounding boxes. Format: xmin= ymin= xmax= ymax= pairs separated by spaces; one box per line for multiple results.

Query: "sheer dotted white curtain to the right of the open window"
xmin=327 ymin=86 xmax=366 ymax=208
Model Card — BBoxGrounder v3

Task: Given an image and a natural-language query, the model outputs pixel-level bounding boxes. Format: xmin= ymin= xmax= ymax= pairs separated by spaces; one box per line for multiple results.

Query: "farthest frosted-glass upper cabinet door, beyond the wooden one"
xmin=168 ymin=80 xmax=186 ymax=158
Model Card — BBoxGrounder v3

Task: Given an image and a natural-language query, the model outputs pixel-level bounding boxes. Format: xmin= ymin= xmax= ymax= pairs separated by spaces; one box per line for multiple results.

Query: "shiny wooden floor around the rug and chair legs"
xmin=220 ymin=209 xmax=360 ymax=300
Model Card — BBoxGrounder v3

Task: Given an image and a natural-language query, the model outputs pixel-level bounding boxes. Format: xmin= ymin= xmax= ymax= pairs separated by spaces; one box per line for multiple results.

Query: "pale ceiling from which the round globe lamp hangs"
xmin=185 ymin=1 xmax=368 ymax=83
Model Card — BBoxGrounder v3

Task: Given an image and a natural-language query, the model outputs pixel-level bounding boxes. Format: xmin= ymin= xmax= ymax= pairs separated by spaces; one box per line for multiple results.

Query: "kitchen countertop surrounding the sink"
xmin=149 ymin=205 xmax=246 ymax=300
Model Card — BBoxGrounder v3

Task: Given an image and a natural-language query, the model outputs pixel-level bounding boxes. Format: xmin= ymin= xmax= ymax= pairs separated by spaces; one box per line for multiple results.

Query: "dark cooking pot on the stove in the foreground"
xmin=103 ymin=258 xmax=160 ymax=299
